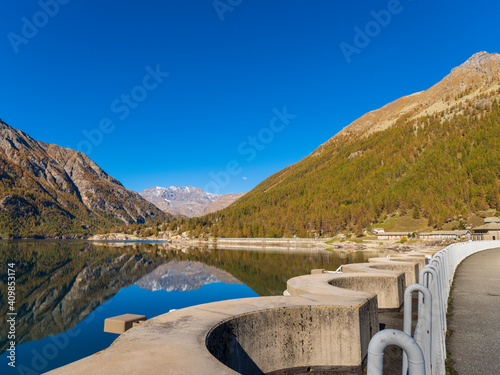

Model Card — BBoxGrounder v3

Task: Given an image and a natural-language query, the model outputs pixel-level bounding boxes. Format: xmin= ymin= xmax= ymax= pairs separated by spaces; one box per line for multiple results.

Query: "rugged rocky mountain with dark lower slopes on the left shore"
xmin=0 ymin=120 xmax=168 ymax=238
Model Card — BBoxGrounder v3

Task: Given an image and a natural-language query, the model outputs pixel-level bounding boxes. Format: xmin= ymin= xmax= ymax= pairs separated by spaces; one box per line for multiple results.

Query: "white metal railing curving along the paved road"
xmin=368 ymin=241 xmax=500 ymax=375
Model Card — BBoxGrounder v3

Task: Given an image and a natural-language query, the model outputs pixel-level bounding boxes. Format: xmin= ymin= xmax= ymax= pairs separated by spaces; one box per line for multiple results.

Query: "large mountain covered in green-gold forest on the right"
xmin=185 ymin=52 xmax=500 ymax=237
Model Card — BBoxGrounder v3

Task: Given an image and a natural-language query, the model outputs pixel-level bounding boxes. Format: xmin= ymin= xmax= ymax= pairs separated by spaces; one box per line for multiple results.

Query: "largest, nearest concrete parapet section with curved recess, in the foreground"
xmin=50 ymin=296 xmax=378 ymax=375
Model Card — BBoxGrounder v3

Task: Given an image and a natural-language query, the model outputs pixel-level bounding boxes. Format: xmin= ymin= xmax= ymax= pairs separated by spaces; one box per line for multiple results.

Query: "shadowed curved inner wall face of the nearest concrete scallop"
xmin=206 ymin=301 xmax=378 ymax=375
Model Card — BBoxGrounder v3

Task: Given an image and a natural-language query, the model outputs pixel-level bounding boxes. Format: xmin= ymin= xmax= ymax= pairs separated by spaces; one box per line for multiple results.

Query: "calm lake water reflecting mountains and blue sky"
xmin=0 ymin=241 xmax=384 ymax=374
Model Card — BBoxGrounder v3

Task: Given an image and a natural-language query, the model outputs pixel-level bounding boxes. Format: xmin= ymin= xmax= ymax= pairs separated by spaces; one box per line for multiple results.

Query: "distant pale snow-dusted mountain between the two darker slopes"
xmin=139 ymin=186 xmax=243 ymax=217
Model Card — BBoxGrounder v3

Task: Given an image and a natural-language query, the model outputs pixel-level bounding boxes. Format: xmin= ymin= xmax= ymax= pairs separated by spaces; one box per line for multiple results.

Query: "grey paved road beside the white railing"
xmin=447 ymin=249 xmax=500 ymax=375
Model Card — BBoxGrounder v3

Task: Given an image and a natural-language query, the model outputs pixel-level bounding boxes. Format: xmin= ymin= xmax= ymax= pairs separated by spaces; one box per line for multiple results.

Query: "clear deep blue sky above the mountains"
xmin=0 ymin=0 xmax=500 ymax=193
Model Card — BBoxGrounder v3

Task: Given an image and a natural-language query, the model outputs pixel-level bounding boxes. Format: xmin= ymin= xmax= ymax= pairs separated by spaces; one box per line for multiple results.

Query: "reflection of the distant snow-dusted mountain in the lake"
xmin=135 ymin=261 xmax=241 ymax=292
